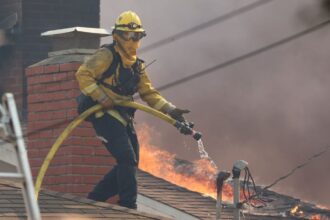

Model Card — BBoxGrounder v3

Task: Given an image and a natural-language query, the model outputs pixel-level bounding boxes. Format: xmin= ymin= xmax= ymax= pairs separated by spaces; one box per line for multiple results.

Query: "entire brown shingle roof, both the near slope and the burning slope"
xmin=0 ymin=171 xmax=330 ymax=220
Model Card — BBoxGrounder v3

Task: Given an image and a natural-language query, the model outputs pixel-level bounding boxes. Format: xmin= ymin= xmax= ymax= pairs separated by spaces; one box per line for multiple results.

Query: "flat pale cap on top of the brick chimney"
xmin=41 ymin=27 xmax=110 ymax=37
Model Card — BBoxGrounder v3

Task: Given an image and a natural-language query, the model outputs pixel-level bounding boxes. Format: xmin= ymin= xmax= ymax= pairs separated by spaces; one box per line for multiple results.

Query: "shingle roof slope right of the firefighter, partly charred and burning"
xmin=138 ymin=170 xmax=330 ymax=220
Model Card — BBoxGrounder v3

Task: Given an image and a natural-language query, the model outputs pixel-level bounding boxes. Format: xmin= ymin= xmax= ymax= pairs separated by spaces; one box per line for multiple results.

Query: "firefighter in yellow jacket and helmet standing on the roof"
xmin=76 ymin=11 xmax=189 ymax=209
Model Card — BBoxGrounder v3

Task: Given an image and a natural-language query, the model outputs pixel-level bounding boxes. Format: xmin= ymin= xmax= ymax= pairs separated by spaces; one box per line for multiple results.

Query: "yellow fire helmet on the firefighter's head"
xmin=112 ymin=11 xmax=145 ymax=32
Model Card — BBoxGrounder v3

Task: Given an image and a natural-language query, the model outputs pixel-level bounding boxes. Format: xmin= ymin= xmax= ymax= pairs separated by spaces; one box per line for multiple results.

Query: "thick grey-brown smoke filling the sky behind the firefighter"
xmin=101 ymin=0 xmax=330 ymax=206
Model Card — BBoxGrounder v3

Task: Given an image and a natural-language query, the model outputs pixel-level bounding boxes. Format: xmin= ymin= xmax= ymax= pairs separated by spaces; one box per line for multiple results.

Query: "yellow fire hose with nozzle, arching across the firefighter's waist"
xmin=35 ymin=101 xmax=202 ymax=200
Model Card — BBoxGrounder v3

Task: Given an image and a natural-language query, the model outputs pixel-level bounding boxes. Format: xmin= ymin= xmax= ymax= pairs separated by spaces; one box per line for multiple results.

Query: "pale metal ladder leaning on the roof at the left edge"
xmin=0 ymin=93 xmax=41 ymax=220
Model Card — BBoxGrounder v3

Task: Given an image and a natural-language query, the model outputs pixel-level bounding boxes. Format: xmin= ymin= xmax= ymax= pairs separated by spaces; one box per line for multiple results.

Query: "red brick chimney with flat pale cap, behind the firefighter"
xmin=25 ymin=27 xmax=115 ymax=196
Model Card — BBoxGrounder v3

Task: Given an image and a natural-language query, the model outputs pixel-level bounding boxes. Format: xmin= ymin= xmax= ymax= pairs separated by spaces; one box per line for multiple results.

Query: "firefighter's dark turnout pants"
xmin=88 ymin=113 xmax=139 ymax=209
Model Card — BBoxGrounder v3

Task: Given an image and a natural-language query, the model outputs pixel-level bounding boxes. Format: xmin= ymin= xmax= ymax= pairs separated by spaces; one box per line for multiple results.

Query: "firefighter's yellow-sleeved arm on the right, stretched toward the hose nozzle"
xmin=138 ymin=68 xmax=176 ymax=114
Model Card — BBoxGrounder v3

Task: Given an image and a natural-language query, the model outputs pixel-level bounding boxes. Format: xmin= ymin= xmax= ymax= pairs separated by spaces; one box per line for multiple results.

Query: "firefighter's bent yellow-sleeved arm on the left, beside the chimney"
xmin=76 ymin=48 xmax=113 ymax=107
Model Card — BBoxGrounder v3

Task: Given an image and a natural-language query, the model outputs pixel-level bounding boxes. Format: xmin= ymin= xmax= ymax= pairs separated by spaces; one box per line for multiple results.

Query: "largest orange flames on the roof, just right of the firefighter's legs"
xmin=138 ymin=125 xmax=233 ymax=201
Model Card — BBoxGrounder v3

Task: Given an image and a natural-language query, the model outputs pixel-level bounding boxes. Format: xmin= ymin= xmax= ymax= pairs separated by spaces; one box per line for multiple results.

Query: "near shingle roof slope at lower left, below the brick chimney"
xmin=0 ymin=185 xmax=167 ymax=220
